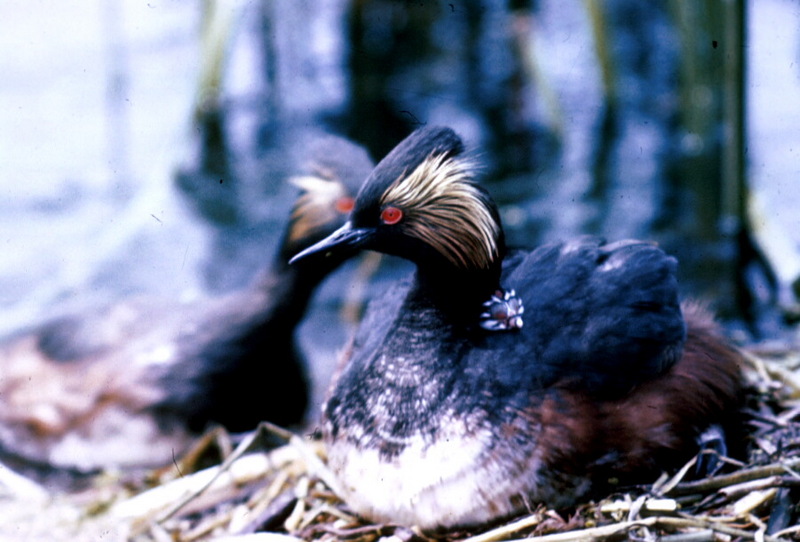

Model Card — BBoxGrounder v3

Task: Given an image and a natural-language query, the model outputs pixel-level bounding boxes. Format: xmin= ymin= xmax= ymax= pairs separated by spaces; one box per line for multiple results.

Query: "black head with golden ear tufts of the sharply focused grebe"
xmin=292 ymin=127 xmax=504 ymax=272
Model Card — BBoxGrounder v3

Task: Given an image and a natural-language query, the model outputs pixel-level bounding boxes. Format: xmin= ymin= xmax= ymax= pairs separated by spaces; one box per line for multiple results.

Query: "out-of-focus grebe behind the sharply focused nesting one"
xmin=0 ymin=138 xmax=372 ymax=470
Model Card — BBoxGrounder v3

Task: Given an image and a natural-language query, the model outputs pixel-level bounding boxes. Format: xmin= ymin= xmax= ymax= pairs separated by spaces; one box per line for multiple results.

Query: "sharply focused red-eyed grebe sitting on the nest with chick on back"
xmin=290 ymin=128 xmax=740 ymax=528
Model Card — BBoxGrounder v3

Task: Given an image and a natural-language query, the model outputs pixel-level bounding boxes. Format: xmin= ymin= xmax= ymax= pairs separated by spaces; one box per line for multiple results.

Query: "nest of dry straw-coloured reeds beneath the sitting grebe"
xmin=3 ymin=350 xmax=800 ymax=542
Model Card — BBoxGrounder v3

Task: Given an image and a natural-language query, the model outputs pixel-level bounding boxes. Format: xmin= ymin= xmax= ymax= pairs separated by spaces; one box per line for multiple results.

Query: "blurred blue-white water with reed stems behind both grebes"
xmin=0 ymin=0 xmax=800 ymax=408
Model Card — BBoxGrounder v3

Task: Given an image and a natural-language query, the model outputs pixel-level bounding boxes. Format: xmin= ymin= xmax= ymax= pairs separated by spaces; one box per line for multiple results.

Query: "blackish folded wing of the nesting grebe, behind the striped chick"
xmin=510 ymin=238 xmax=686 ymax=395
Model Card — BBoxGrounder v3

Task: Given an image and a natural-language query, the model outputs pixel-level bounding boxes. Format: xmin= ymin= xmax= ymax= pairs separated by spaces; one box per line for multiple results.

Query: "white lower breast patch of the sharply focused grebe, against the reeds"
xmin=328 ymin=406 xmax=588 ymax=529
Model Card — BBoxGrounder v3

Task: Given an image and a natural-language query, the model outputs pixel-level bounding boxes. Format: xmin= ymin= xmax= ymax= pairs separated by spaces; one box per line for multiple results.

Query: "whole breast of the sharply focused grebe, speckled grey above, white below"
xmin=316 ymin=288 xmax=589 ymax=529
